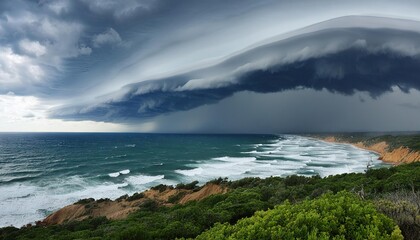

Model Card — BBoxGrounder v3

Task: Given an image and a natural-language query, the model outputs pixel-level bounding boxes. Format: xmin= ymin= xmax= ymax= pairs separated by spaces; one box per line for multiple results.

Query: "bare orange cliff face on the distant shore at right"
xmin=322 ymin=137 xmax=420 ymax=164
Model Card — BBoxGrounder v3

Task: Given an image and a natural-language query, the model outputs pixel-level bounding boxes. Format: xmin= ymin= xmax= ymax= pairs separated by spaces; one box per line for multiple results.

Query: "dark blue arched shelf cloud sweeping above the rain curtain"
xmin=52 ymin=18 xmax=420 ymax=122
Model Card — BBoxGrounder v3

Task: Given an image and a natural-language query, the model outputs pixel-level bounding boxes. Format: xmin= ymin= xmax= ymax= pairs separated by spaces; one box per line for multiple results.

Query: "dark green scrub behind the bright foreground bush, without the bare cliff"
xmin=0 ymin=163 xmax=420 ymax=240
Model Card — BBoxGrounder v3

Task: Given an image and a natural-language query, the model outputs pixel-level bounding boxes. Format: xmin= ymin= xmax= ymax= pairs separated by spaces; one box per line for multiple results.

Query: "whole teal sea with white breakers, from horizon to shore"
xmin=0 ymin=133 xmax=387 ymax=227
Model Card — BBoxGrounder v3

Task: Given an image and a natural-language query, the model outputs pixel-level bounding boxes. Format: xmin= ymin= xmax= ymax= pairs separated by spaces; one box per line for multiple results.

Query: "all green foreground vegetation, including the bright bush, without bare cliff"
xmin=0 ymin=163 xmax=420 ymax=240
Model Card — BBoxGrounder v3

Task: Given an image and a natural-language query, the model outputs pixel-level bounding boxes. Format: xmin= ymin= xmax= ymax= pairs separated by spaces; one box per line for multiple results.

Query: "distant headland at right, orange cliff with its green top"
xmin=310 ymin=135 xmax=420 ymax=165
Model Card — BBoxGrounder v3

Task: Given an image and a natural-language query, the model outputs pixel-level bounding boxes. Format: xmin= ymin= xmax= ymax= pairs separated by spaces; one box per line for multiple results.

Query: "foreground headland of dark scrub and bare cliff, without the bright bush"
xmin=4 ymin=162 xmax=420 ymax=239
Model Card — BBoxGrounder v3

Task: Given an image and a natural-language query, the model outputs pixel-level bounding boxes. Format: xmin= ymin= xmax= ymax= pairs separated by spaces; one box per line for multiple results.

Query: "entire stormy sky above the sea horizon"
xmin=0 ymin=0 xmax=420 ymax=133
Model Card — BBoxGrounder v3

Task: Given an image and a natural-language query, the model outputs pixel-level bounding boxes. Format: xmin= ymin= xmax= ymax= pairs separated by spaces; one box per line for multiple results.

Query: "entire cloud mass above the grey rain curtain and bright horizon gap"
xmin=0 ymin=0 xmax=420 ymax=132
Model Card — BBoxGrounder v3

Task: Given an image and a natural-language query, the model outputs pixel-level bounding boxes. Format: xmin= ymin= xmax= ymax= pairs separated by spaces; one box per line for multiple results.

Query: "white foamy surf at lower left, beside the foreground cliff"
xmin=0 ymin=176 xmax=132 ymax=227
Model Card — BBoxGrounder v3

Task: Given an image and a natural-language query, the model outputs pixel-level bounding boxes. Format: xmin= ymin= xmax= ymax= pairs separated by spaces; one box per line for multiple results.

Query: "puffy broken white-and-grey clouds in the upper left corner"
xmin=0 ymin=1 xmax=91 ymax=95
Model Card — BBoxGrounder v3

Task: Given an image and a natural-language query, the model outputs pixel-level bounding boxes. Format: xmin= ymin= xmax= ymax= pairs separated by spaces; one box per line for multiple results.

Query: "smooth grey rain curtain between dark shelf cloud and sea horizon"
xmin=136 ymin=88 xmax=420 ymax=134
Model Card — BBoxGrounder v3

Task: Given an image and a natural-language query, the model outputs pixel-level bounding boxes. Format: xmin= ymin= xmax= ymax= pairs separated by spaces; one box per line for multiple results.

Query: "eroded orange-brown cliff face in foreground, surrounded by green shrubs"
xmin=38 ymin=184 xmax=228 ymax=225
